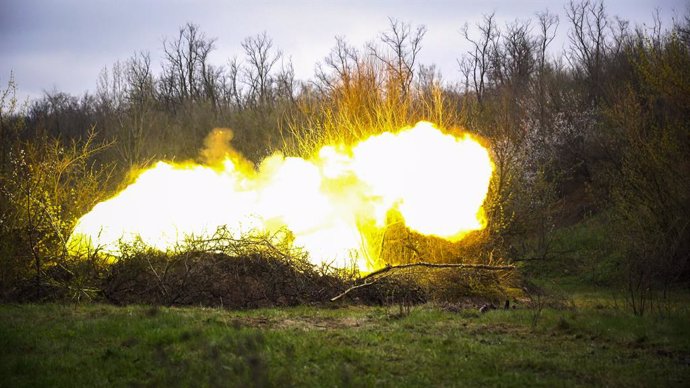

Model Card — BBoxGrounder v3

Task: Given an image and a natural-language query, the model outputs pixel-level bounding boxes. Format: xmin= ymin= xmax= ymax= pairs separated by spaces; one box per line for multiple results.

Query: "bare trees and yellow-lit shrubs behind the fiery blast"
xmin=0 ymin=0 xmax=690 ymax=310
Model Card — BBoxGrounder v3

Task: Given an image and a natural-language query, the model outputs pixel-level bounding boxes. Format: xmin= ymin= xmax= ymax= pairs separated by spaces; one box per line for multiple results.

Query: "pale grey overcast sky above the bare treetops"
xmin=0 ymin=0 xmax=688 ymax=102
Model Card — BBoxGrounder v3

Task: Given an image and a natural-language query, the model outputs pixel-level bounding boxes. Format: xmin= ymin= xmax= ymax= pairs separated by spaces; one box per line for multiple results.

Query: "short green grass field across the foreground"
xmin=0 ymin=298 xmax=690 ymax=387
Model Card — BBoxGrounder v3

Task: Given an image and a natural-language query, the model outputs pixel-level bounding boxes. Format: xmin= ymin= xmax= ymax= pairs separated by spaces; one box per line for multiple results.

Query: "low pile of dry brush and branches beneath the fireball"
xmin=6 ymin=226 xmax=517 ymax=309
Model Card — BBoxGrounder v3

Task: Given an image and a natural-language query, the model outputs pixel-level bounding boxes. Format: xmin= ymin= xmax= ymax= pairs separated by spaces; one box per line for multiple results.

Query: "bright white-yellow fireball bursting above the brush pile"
xmin=69 ymin=122 xmax=493 ymax=271
